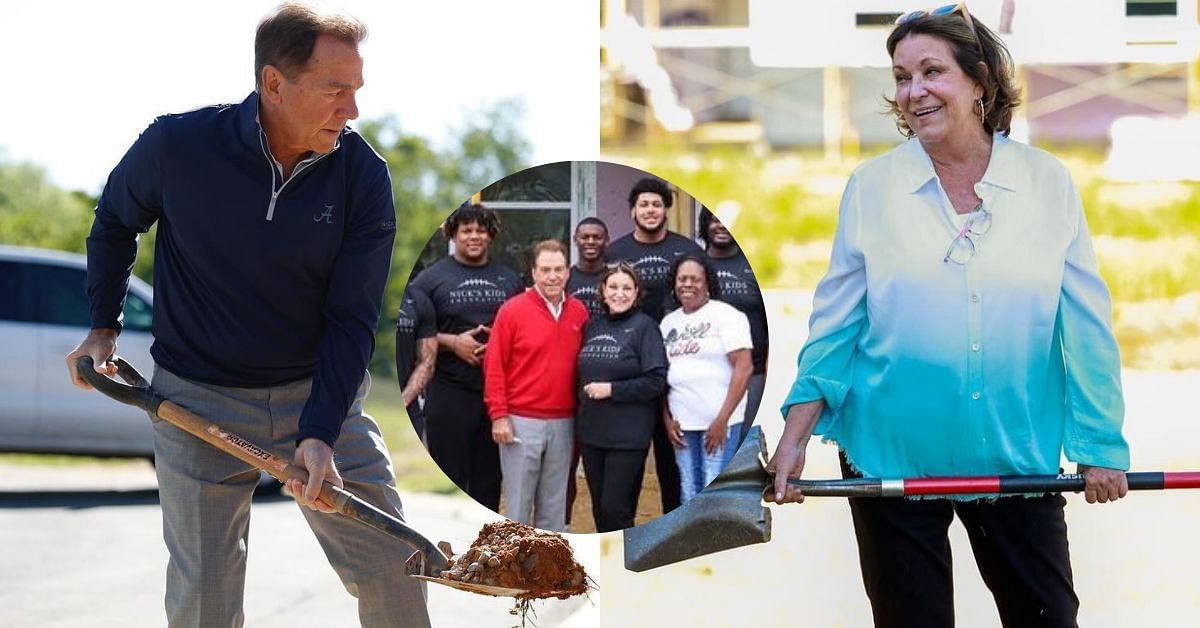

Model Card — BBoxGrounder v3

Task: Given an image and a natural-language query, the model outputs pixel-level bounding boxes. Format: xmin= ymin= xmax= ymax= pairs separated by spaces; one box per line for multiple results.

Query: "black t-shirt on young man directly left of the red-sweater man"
xmin=413 ymin=257 xmax=524 ymax=390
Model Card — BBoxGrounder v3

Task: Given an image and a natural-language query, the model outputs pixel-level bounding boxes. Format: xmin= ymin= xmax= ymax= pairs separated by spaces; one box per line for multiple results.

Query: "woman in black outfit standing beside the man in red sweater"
xmin=575 ymin=262 xmax=667 ymax=532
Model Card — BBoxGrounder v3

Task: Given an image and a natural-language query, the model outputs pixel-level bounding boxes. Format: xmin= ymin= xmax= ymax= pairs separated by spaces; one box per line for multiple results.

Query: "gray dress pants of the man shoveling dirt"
xmin=152 ymin=367 xmax=430 ymax=628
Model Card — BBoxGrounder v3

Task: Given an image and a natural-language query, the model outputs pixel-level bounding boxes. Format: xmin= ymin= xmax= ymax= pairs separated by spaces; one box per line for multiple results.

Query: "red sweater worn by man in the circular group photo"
xmin=484 ymin=288 xmax=588 ymax=420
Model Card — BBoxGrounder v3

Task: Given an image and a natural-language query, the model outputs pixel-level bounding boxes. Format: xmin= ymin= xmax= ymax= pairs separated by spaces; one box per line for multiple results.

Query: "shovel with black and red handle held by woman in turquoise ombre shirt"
xmin=625 ymin=426 xmax=1200 ymax=572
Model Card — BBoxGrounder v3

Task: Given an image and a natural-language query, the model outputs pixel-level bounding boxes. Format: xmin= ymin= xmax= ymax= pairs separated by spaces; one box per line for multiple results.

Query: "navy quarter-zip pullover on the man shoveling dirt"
xmin=88 ymin=92 xmax=396 ymax=447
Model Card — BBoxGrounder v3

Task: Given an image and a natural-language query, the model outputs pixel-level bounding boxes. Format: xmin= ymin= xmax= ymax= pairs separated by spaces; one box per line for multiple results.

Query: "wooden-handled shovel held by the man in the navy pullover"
xmin=76 ymin=355 xmax=540 ymax=597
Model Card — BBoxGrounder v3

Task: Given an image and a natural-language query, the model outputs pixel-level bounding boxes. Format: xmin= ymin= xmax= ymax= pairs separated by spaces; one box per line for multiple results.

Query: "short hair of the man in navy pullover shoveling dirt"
xmin=254 ymin=2 xmax=367 ymax=88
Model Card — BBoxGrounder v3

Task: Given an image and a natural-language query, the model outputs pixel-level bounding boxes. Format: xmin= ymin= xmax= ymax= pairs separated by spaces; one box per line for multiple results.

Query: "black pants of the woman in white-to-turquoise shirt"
xmin=841 ymin=457 xmax=1079 ymax=628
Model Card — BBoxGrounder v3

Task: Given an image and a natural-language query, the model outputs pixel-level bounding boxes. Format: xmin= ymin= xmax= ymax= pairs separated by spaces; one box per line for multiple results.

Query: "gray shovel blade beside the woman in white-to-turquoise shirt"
xmin=624 ymin=426 xmax=770 ymax=572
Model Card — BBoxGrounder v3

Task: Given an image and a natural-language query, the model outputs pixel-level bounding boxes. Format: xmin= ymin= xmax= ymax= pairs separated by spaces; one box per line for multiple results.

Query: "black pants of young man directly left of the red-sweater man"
xmin=425 ymin=377 xmax=500 ymax=512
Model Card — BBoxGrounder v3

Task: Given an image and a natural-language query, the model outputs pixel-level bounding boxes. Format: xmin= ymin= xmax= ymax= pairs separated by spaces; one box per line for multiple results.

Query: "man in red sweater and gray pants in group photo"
xmin=484 ymin=240 xmax=588 ymax=532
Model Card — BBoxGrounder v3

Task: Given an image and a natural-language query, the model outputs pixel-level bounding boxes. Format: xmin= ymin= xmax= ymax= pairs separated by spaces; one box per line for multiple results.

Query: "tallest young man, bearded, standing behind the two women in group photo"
xmin=605 ymin=178 xmax=704 ymax=513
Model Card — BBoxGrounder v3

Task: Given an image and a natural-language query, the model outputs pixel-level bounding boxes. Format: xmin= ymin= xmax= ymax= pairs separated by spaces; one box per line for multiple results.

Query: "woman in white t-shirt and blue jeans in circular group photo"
xmin=659 ymin=253 xmax=754 ymax=502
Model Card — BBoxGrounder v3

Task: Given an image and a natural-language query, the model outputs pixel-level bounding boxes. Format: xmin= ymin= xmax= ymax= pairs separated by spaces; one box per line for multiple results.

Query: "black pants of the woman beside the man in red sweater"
xmin=583 ymin=444 xmax=647 ymax=532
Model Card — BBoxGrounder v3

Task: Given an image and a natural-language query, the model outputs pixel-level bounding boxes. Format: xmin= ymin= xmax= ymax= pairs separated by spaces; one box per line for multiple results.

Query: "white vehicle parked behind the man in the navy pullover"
xmin=0 ymin=245 xmax=154 ymax=457
